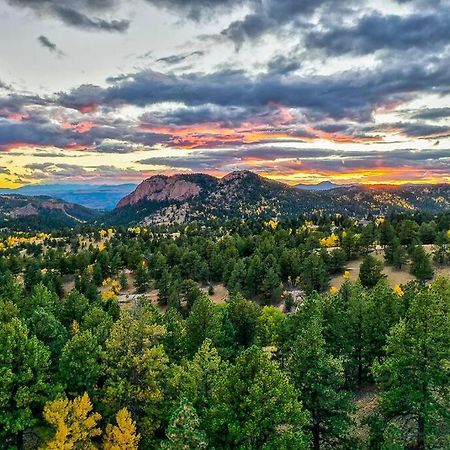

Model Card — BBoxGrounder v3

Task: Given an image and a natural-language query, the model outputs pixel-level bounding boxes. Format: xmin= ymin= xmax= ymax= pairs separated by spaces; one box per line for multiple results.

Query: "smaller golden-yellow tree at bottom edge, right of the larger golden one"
xmin=103 ymin=408 xmax=140 ymax=450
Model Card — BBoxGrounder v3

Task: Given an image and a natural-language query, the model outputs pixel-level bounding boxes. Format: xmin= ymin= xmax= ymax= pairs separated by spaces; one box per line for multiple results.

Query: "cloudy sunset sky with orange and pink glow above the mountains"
xmin=0 ymin=0 xmax=450 ymax=187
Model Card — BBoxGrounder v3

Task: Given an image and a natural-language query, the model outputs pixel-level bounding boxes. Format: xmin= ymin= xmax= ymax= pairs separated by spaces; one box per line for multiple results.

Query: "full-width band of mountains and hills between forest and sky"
xmin=4 ymin=171 xmax=450 ymax=228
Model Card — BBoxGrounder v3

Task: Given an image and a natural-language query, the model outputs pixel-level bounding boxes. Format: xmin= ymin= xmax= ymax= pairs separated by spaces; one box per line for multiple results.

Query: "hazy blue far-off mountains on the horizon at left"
xmin=0 ymin=184 xmax=136 ymax=211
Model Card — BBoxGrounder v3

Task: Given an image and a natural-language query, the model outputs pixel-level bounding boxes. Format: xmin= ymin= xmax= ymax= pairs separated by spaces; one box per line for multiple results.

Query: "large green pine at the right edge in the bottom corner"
xmin=374 ymin=284 xmax=450 ymax=450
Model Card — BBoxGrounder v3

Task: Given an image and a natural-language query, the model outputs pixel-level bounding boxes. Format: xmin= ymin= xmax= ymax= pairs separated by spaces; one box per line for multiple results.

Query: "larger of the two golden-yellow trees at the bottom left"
xmin=42 ymin=393 xmax=102 ymax=450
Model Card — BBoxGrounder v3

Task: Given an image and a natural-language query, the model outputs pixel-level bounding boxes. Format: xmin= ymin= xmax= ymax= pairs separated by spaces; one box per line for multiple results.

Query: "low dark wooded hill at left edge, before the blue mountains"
xmin=0 ymin=194 xmax=99 ymax=230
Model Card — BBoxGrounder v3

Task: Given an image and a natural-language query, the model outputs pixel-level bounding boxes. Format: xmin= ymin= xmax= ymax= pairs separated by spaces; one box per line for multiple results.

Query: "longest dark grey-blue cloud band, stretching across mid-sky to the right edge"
xmin=57 ymin=48 xmax=450 ymax=121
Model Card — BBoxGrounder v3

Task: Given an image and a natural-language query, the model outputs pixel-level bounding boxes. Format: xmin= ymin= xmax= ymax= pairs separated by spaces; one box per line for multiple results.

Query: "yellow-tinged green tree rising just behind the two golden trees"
xmin=102 ymin=310 xmax=168 ymax=442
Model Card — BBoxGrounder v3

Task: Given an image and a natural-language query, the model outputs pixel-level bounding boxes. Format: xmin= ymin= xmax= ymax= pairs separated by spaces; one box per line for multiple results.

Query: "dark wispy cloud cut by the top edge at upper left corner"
xmin=8 ymin=0 xmax=130 ymax=33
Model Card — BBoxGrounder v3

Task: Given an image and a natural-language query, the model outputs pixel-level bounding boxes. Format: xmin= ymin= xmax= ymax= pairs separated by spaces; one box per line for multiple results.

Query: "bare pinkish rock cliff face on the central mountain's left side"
xmin=117 ymin=175 xmax=207 ymax=208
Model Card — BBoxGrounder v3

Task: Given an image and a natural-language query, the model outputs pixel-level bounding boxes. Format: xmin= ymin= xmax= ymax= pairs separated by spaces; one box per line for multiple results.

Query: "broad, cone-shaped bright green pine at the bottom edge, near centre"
xmin=208 ymin=347 xmax=309 ymax=450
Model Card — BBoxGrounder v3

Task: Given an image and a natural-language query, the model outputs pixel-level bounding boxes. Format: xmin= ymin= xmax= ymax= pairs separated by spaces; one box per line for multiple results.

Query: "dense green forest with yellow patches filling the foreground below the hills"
xmin=0 ymin=214 xmax=450 ymax=450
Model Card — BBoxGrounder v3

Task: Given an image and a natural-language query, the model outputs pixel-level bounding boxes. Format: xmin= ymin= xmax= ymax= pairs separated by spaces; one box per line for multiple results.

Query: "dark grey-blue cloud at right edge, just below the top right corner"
xmin=305 ymin=11 xmax=450 ymax=55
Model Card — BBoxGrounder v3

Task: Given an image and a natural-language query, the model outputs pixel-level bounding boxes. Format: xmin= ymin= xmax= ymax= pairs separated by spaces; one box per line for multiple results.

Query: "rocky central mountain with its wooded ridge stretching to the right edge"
xmin=104 ymin=171 xmax=450 ymax=225
